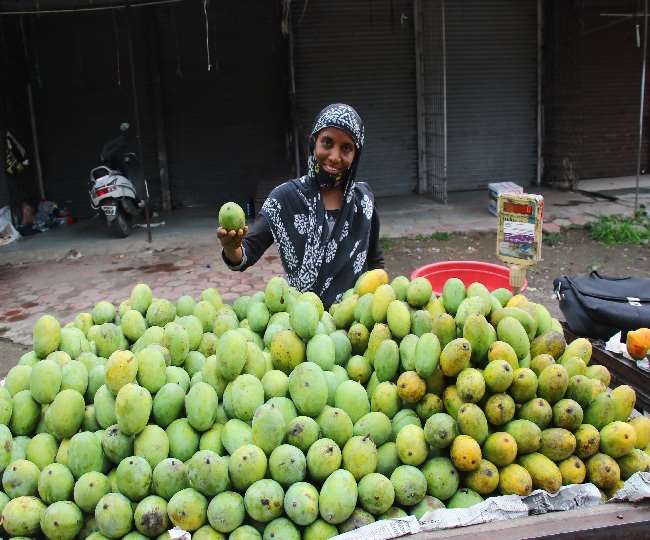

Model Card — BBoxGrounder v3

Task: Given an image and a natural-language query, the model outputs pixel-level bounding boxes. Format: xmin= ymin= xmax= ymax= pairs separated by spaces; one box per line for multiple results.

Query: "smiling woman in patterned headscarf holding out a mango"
xmin=217 ymin=103 xmax=384 ymax=307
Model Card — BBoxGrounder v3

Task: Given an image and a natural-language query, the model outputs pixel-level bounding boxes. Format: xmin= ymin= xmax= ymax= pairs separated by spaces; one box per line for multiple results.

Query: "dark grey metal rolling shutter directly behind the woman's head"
xmin=292 ymin=0 xmax=417 ymax=196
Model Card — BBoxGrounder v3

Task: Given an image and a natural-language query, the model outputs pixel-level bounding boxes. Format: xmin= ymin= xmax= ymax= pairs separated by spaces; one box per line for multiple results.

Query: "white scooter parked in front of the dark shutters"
xmin=88 ymin=123 xmax=144 ymax=238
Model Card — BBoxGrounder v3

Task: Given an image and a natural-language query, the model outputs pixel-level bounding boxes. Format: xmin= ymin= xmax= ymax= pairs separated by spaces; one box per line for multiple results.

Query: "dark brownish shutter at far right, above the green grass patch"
xmin=544 ymin=0 xmax=650 ymax=183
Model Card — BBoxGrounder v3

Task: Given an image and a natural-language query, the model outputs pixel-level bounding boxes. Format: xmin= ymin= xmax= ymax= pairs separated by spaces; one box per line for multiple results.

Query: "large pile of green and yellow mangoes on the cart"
xmin=0 ymin=270 xmax=650 ymax=540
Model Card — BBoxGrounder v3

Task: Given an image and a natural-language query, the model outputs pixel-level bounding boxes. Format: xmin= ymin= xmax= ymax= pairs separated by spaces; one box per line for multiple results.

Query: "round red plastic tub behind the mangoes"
xmin=411 ymin=261 xmax=528 ymax=295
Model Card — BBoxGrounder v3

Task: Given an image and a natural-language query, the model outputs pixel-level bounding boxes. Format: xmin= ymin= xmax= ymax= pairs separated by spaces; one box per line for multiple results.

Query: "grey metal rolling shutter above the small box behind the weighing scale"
xmin=446 ymin=0 xmax=537 ymax=191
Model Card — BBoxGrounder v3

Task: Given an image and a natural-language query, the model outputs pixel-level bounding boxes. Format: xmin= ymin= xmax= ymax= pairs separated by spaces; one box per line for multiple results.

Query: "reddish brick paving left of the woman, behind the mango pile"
xmin=0 ymin=240 xmax=282 ymax=345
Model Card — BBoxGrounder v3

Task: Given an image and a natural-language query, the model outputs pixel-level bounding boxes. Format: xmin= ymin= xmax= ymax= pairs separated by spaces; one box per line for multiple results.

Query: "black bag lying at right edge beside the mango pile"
xmin=553 ymin=272 xmax=650 ymax=340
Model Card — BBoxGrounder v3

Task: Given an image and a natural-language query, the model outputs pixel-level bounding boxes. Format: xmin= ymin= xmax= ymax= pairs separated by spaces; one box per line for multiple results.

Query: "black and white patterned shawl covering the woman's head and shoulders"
xmin=260 ymin=103 xmax=375 ymax=307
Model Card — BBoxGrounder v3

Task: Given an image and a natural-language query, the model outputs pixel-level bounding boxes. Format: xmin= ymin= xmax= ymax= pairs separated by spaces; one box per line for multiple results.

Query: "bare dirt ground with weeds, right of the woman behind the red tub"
xmin=383 ymin=229 xmax=650 ymax=319
